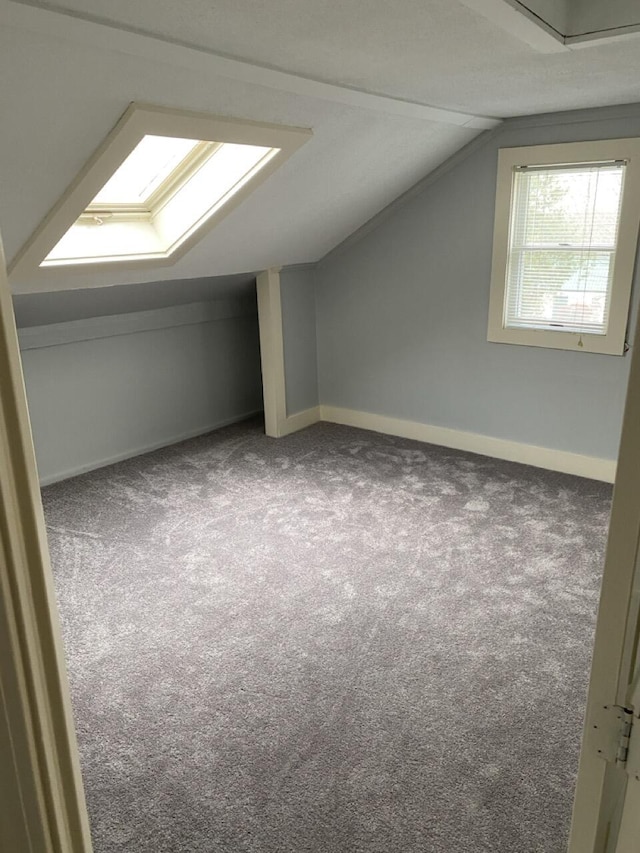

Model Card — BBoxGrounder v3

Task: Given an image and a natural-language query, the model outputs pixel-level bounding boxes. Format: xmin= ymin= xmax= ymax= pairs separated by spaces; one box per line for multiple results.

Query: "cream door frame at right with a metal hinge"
xmin=569 ymin=296 xmax=640 ymax=853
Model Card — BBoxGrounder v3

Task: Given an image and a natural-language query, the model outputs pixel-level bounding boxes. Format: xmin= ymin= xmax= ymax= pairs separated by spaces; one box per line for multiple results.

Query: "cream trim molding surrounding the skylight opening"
xmin=8 ymin=103 xmax=312 ymax=282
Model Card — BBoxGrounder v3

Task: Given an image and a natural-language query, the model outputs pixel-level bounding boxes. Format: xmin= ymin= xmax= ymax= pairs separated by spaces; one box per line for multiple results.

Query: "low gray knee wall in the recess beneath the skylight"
xmin=21 ymin=299 xmax=262 ymax=482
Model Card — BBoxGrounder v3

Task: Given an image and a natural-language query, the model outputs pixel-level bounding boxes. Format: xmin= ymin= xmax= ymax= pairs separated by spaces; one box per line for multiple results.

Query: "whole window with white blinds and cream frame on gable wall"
xmin=488 ymin=139 xmax=640 ymax=355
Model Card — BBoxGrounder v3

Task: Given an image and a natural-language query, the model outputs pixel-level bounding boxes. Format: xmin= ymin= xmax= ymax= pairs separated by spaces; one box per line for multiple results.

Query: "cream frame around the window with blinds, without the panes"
xmin=487 ymin=138 xmax=640 ymax=355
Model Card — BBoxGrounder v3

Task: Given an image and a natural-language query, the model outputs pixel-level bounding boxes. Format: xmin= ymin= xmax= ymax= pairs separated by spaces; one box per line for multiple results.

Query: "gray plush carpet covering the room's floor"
xmin=44 ymin=422 xmax=611 ymax=853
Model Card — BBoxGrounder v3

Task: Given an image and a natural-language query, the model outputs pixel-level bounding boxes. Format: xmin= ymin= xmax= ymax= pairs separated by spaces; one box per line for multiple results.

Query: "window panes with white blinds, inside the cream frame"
xmin=504 ymin=163 xmax=625 ymax=335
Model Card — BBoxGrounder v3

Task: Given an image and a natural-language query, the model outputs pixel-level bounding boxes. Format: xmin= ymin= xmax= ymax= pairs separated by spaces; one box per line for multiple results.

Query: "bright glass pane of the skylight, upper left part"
xmin=91 ymin=136 xmax=199 ymax=206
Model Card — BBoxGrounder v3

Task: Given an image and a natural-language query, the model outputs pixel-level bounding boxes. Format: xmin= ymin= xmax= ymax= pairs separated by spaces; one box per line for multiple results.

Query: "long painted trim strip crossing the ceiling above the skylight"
xmin=2 ymin=0 xmax=502 ymax=130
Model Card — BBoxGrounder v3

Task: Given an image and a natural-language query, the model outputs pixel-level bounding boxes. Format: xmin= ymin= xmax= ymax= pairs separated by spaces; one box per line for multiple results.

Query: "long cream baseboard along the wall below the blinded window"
xmin=320 ymin=406 xmax=617 ymax=483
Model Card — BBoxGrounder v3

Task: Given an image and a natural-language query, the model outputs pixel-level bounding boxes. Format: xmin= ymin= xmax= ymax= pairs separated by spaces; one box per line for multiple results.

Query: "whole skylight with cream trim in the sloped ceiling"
xmin=10 ymin=104 xmax=311 ymax=279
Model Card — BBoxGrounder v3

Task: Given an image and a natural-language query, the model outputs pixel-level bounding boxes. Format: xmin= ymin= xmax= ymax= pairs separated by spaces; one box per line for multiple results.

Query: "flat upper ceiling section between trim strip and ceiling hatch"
xmin=11 ymin=0 xmax=640 ymax=117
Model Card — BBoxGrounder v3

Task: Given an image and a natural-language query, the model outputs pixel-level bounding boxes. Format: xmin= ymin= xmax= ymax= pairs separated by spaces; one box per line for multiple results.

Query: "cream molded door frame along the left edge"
xmin=0 ymin=235 xmax=92 ymax=853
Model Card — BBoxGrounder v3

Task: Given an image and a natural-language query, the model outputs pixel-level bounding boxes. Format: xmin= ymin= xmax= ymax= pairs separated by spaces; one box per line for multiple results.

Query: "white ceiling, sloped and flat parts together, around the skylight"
xmin=0 ymin=0 xmax=640 ymax=291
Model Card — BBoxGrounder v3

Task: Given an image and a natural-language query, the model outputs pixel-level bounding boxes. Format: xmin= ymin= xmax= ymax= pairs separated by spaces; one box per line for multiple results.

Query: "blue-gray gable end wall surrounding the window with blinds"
xmin=316 ymin=105 xmax=640 ymax=459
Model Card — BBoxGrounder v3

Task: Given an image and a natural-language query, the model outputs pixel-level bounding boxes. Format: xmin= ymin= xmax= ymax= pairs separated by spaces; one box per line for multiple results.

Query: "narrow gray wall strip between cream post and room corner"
xmin=280 ymin=267 xmax=318 ymax=415
